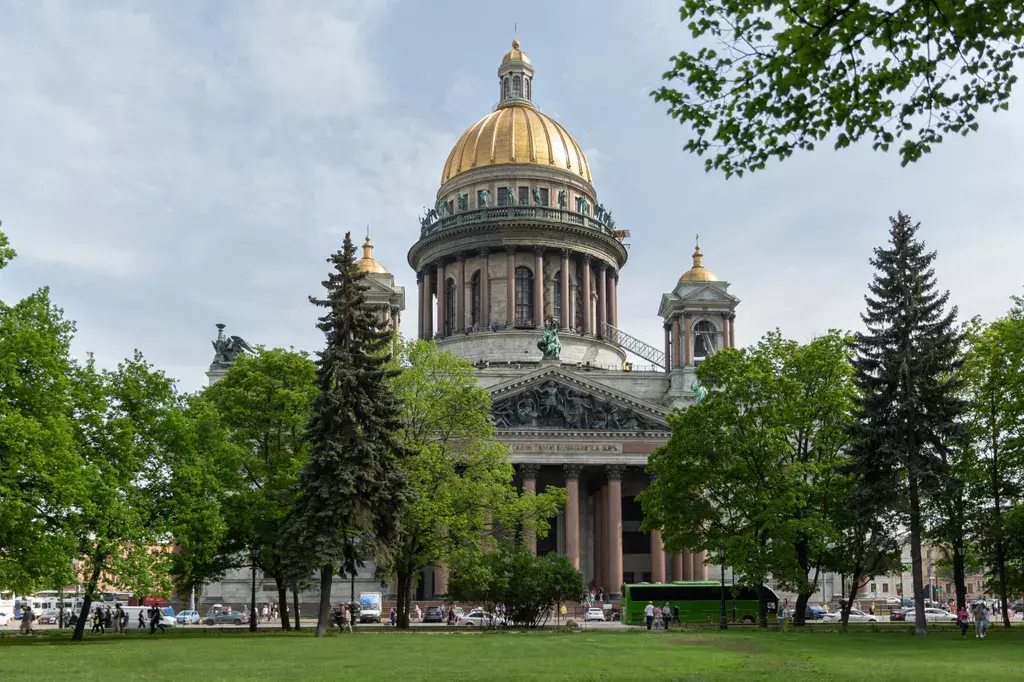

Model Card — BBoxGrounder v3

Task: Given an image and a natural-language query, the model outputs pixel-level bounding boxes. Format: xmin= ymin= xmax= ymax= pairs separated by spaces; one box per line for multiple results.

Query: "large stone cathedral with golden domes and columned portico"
xmin=204 ymin=42 xmax=739 ymax=602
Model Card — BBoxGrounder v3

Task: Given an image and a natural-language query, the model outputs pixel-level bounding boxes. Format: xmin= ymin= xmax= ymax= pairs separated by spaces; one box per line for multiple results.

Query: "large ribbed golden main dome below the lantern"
xmin=441 ymin=104 xmax=591 ymax=184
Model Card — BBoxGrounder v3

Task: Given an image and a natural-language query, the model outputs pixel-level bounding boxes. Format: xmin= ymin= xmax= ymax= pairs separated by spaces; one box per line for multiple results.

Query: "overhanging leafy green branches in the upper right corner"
xmin=652 ymin=0 xmax=1024 ymax=177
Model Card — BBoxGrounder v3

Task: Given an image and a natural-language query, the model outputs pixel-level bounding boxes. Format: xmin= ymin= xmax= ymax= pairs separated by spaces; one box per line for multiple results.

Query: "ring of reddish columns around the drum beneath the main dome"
xmin=417 ymin=246 xmax=618 ymax=339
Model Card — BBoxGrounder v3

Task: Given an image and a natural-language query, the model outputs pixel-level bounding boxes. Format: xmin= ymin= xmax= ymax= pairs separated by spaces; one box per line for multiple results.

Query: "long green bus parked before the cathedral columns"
xmin=620 ymin=581 xmax=778 ymax=625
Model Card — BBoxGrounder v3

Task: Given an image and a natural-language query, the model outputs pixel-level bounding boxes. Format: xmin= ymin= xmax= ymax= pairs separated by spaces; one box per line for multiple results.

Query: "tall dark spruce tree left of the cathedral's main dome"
xmin=286 ymin=233 xmax=411 ymax=637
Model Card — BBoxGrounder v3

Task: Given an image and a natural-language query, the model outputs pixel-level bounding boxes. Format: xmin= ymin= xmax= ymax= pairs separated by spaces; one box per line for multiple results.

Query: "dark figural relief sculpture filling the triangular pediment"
xmin=493 ymin=381 xmax=667 ymax=431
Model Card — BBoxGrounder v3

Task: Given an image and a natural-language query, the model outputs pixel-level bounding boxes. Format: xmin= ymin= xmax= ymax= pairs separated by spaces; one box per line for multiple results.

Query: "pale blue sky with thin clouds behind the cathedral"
xmin=0 ymin=0 xmax=1024 ymax=390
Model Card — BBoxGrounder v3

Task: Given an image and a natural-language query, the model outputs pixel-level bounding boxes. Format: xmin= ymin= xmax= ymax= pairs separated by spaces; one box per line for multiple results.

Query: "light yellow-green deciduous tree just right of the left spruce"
xmin=390 ymin=341 xmax=565 ymax=628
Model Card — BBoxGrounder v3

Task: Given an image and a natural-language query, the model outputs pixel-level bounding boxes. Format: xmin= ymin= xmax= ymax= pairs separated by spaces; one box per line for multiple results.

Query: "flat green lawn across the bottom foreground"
xmin=0 ymin=630 xmax=1024 ymax=682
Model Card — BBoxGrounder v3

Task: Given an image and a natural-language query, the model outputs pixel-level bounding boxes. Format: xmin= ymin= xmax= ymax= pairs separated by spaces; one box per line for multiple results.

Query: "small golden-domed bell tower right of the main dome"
xmin=657 ymin=237 xmax=739 ymax=407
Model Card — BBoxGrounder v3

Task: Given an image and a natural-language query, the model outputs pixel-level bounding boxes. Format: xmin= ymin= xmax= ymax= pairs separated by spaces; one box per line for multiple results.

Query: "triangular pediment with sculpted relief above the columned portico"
xmin=490 ymin=367 xmax=671 ymax=435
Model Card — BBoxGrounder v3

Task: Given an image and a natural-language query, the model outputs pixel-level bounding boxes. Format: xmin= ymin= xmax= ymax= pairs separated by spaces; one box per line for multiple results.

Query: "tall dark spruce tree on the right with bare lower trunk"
xmin=854 ymin=213 xmax=964 ymax=635
